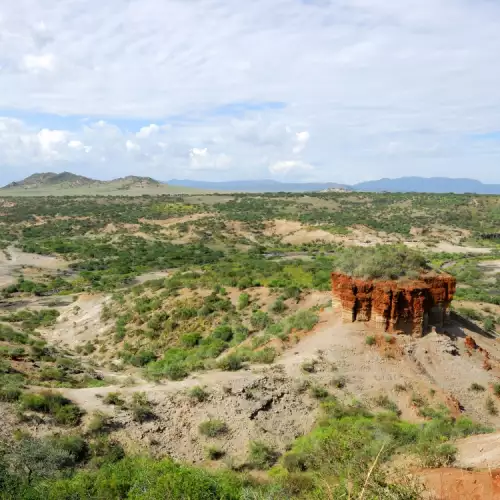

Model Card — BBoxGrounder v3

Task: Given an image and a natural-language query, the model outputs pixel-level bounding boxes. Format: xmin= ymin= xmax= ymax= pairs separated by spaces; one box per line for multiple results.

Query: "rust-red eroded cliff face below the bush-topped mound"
xmin=332 ymin=273 xmax=456 ymax=337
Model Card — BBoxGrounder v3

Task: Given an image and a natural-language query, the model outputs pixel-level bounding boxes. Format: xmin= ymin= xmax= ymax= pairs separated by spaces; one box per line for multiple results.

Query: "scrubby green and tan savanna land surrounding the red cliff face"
xmin=0 ymin=178 xmax=500 ymax=500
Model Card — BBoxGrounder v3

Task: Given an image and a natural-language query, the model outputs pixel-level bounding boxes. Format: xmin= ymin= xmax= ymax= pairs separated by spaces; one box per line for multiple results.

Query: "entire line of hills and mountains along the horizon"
xmin=1 ymin=172 xmax=500 ymax=195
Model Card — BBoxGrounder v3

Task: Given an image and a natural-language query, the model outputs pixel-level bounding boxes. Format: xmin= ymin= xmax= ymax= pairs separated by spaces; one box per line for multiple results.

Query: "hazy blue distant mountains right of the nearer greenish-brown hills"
xmin=168 ymin=177 xmax=500 ymax=194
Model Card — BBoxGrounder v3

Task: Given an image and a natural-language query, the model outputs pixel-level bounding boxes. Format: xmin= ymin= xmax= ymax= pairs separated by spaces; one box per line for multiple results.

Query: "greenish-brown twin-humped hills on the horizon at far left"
xmin=2 ymin=172 xmax=162 ymax=190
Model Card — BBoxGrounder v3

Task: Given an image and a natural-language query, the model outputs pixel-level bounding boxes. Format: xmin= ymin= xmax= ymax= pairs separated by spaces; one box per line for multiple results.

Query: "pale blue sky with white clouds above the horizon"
xmin=0 ymin=0 xmax=500 ymax=184
